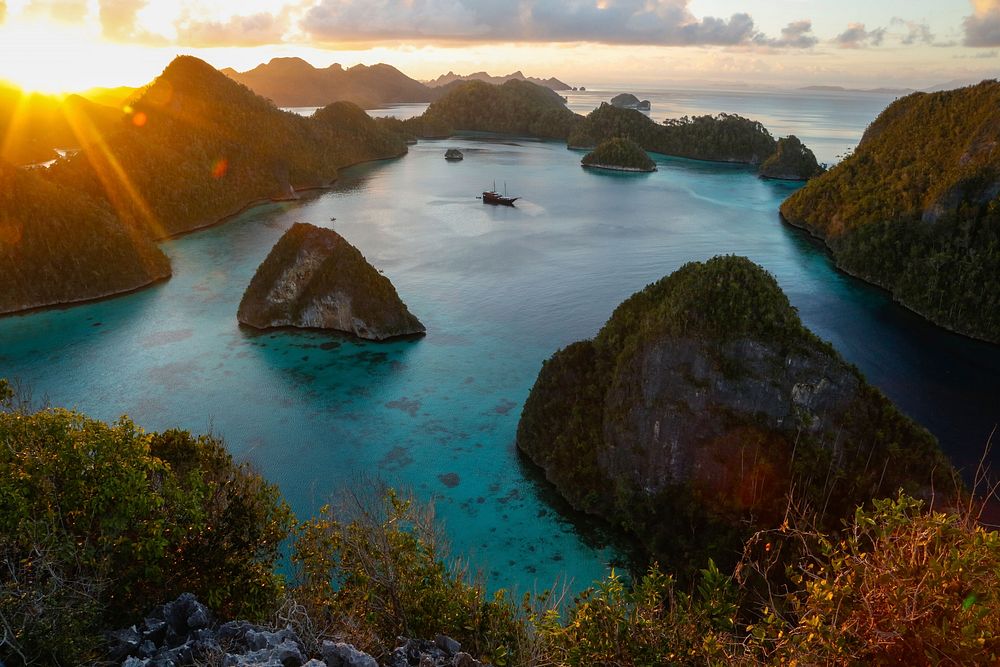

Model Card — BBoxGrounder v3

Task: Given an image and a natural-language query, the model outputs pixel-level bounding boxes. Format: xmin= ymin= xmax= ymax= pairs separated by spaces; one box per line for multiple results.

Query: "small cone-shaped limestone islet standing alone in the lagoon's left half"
xmin=237 ymin=222 xmax=426 ymax=340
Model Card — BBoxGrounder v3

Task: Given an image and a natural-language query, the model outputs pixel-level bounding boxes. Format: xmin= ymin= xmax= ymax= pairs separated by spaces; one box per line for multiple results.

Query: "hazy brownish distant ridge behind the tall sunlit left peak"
xmin=222 ymin=58 xmax=433 ymax=109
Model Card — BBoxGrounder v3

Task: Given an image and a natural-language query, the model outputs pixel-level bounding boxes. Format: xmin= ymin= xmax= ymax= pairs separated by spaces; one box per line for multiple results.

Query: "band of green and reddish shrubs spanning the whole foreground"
xmin=0 ymin=381 xmax=1000 ymax=667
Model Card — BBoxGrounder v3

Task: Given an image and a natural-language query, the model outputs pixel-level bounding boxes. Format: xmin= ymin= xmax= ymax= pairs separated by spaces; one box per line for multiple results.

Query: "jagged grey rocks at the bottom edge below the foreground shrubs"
xmin=107 ymin=593 xmax=482 ymax=667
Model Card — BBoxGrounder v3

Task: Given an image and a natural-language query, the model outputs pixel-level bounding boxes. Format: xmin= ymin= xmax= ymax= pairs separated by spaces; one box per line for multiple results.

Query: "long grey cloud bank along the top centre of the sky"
xmin=301 ymin=0 xmax=758 ymax=46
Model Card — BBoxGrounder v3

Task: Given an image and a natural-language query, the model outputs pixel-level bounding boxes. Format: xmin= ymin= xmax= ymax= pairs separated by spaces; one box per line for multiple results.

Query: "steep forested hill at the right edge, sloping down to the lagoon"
xmin=781 ymin=81 xmax=1000 ymax=342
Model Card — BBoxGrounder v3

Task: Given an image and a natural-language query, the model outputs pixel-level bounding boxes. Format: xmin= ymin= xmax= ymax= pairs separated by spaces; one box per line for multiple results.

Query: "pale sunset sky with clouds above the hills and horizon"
xmin=0 ymin=0 xmax=1000 ymax=92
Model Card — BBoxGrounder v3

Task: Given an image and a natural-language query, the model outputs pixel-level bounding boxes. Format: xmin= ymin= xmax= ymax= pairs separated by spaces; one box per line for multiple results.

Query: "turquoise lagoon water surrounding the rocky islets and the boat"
xmin=0 ymin=136 xmax=1000 ymax=590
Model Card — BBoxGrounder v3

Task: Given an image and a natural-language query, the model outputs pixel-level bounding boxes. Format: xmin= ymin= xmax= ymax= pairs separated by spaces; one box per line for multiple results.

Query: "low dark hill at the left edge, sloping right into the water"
xmin=0 ymin=163 xmax=170 ymax=313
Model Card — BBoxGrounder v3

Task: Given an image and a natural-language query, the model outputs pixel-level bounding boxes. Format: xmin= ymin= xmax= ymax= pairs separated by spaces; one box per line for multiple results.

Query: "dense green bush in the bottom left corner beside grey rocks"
xmin=0 ymin=400 xmax=291 ymax=664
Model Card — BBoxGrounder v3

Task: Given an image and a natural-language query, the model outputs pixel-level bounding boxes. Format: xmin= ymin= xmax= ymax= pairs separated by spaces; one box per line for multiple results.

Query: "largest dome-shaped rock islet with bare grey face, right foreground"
xmin=517 ymin=257 xmax=951 ymax=559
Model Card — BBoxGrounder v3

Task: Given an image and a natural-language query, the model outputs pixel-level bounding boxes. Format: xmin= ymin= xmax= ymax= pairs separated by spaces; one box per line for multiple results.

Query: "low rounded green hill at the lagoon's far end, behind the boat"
xmin=406 ymin=79 xmax=580 ymax=139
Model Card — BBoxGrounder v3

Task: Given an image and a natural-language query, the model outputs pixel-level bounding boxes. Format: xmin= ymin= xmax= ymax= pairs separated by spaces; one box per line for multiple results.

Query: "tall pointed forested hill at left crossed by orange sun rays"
xmin=50 ymin=56 xmax=406 ymax=238
